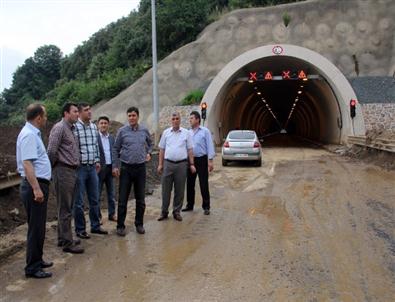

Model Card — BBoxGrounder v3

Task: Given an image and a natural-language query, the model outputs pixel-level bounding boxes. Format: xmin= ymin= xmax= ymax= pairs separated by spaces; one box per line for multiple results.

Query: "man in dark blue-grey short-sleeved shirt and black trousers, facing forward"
xmin=113 ymin=107 xmax=152 ymax=236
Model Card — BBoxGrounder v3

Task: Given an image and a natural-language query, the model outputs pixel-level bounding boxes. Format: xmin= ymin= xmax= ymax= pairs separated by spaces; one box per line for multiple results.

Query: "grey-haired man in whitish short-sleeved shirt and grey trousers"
xmin=158 ymin=112 xmax=196 ymax=221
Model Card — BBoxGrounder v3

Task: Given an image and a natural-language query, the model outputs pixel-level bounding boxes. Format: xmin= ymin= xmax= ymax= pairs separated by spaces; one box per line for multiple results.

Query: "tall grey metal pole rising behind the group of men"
xmin=151 ymin=0 xmax=159 ymax=146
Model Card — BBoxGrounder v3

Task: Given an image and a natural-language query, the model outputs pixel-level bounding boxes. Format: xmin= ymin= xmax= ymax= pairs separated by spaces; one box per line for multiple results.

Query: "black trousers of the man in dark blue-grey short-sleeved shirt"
xmin=117 ymin=163 xmax=146 ymax=229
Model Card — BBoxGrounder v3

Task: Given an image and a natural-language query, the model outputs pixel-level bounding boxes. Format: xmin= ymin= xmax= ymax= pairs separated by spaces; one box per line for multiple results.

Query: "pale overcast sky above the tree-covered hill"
xmin=0 ymin=0 xmax=140 ymax=93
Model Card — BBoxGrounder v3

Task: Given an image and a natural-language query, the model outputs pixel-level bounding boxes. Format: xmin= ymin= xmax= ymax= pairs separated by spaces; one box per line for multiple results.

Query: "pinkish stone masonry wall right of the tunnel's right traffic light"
xmin=361 ymin=103 xmax=395 ymax=132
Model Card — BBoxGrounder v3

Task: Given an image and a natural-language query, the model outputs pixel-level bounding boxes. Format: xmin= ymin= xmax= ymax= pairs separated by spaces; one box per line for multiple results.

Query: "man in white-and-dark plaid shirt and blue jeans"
xmin=74 ymin=103 xmax=108 ymax=239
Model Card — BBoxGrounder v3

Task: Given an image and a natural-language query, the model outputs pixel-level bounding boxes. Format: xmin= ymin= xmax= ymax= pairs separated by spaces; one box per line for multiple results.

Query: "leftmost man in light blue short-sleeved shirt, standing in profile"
xmin=16 ymin=104 xmax=53 ymax=278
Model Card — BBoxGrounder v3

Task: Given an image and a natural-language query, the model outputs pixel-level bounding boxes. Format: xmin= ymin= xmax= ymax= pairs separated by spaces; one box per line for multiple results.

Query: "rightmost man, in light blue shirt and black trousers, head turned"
xmin=182 ymin=111 xmax=215 ymax=215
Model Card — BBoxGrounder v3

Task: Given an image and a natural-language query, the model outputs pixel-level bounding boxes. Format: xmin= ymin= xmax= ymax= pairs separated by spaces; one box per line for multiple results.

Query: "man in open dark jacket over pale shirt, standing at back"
xmin=97 ymin=116 xmax=117 ymax=221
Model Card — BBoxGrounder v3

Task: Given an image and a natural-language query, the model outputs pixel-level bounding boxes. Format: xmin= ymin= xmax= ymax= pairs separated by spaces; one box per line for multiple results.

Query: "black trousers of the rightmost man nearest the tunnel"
xmin=187 ymin=155 xmax=210 ymax=210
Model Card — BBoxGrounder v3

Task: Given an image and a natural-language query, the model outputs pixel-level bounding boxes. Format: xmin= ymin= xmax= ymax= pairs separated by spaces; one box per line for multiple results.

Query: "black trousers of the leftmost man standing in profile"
xmin=20 ymin=178 xmax=49 ymax=274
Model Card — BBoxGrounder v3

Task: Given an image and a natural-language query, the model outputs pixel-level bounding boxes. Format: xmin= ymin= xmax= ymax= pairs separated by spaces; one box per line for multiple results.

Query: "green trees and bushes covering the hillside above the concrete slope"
xmin=0 ymin=0 xmax=301 ymax=123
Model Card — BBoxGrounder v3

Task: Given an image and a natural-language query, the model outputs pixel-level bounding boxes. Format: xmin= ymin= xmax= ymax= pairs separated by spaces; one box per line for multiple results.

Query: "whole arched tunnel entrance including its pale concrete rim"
xmin=202 ymin=45 xmax=364 ymax=144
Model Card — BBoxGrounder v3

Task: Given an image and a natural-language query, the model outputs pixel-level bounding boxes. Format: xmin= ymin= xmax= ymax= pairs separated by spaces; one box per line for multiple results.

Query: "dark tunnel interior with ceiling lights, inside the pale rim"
xmin=216 ymin=56 xmax=341 ymax=143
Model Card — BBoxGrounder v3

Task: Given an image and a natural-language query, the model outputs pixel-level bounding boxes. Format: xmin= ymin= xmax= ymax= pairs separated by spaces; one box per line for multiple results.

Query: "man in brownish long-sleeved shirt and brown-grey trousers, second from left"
xmin=48 ymin=103 xmax=84 ymax=254
